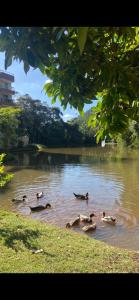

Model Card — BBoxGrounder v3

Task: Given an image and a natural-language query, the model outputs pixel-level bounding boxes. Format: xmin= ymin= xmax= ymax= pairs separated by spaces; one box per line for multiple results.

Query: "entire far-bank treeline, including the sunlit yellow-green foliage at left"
xmin=0 ymin=94 xmax=96 ymax=149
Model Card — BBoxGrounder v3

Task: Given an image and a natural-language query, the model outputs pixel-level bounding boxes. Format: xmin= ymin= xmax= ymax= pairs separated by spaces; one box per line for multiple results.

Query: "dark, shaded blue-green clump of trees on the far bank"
xmin=16 ymin=95 xmax=95 ymax=146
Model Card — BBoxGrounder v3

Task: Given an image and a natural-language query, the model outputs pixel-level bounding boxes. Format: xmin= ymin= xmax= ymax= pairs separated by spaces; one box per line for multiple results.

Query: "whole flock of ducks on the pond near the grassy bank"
xmin=12 ymin=192 xmax=116 ymax=232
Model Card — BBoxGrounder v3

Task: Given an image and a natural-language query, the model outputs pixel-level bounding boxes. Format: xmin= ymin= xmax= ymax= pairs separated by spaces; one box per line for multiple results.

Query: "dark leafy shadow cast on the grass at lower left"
xmin=0 ymin=227 xmax=41 ymax=251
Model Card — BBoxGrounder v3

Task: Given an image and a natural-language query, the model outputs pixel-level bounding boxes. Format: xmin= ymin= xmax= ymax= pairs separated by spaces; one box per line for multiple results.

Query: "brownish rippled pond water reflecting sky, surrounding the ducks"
xmin=0 ymin=147 xmax=139 ymax=250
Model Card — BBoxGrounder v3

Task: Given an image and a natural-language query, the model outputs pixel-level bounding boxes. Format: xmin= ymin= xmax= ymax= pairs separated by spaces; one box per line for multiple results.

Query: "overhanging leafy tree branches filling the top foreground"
xmin=0 ymin=27 xmax=139 ymax=141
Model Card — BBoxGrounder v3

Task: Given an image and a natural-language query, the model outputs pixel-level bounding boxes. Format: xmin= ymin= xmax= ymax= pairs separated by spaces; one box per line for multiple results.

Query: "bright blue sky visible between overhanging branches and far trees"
xmin=0 ymin=52 xmax=92 ymax=121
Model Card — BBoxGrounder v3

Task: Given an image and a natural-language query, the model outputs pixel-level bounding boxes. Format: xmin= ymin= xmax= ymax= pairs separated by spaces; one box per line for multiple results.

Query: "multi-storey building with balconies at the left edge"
xmin=0 ymin=70 xmax=15 ymax=106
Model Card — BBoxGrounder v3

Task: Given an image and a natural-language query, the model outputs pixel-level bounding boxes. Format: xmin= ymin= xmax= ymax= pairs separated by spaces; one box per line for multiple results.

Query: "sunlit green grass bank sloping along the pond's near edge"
xmin=0 ymin=210 xmax=139 ymax=273
